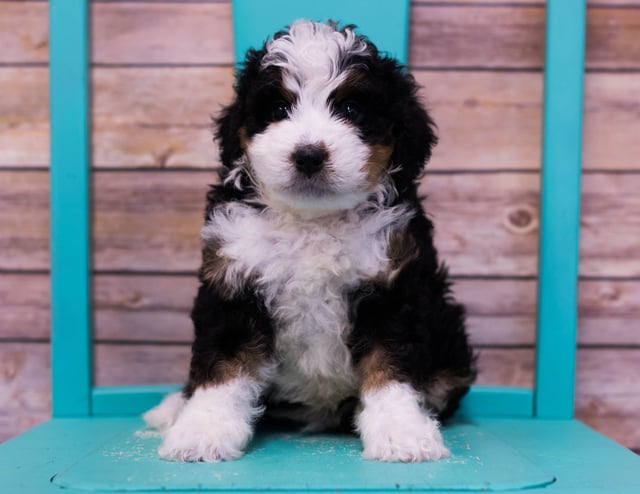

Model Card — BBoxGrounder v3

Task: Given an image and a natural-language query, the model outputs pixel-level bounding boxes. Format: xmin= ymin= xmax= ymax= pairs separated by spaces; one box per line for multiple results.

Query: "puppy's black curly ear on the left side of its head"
xmin=214 ymin=49 xmax=265 ymax=169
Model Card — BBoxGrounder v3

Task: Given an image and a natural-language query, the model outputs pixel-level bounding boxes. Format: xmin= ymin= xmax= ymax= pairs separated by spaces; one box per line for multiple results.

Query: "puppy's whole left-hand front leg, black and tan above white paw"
xmin=158 ymin=285 xmax=274 ymax=461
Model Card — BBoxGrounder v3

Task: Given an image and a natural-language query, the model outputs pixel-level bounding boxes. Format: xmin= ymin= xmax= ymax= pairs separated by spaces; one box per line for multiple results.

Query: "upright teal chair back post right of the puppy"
xmin=536 ymin=0 xmax=586 ymax=418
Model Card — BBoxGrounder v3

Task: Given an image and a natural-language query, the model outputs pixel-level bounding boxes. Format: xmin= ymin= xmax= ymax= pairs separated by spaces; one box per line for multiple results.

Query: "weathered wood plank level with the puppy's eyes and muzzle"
xmin=5 ymin=67 xmax=640 ymax=171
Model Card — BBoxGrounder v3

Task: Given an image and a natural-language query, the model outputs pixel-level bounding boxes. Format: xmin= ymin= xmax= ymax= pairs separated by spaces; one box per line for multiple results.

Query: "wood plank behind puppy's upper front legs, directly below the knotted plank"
xmin=0 ymin=274 xmax=640 ymax=346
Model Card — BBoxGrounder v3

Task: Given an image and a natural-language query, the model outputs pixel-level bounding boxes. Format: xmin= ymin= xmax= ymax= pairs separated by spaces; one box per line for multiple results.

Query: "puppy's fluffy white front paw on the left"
xmin=158 ymin=376 xmax=263 ymax=461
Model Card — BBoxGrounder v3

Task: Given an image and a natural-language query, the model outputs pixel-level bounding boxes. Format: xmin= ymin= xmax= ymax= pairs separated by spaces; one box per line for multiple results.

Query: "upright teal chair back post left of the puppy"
xmin=49 ymin=0 xmax=92 ymax=417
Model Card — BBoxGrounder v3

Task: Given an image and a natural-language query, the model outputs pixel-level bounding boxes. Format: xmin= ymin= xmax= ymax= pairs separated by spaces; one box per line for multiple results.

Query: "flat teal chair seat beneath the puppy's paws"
xmin=0 ymin=417 xmax=640 ymax=494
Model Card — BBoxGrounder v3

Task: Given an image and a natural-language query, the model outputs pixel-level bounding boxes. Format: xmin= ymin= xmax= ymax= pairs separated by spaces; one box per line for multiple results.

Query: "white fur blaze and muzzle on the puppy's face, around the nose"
xmin=240 ymin=21 xmax=376 ymax=217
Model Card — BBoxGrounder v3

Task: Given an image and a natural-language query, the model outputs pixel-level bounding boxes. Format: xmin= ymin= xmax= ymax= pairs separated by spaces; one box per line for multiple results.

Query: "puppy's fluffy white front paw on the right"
xmin=357 ymin=381 xmax=450 ymax=462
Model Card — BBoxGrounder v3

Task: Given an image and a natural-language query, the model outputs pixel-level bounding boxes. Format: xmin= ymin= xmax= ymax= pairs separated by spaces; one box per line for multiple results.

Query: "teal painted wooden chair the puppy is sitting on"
xmin=0 ymin=0 xmax=640 ymax=494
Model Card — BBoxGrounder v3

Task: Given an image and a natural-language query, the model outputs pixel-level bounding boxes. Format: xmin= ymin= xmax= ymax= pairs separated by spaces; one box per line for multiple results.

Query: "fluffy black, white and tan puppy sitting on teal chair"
xmin=145 ymin=21 xmax=475 ymax=462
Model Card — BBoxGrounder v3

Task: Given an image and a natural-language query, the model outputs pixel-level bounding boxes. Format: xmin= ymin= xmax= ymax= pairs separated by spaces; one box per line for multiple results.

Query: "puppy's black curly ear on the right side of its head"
xmin=384 ymin=65 xmax=438 ymax=189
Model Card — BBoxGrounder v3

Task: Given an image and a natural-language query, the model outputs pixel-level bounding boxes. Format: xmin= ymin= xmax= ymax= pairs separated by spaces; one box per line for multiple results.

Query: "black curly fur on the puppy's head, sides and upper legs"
xmin=185 ymin=22 xmax=476 ymax=424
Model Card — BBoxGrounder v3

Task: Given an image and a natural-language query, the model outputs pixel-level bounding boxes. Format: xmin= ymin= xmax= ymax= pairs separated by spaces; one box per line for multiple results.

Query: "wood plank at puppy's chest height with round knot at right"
xmin=0 ymin=170 xmax=640 ymax=278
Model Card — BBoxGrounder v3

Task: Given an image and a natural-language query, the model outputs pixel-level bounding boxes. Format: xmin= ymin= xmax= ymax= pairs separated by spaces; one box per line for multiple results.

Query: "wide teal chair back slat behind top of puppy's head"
xmin=232 ymin=0 xmax=409 ymax=64
